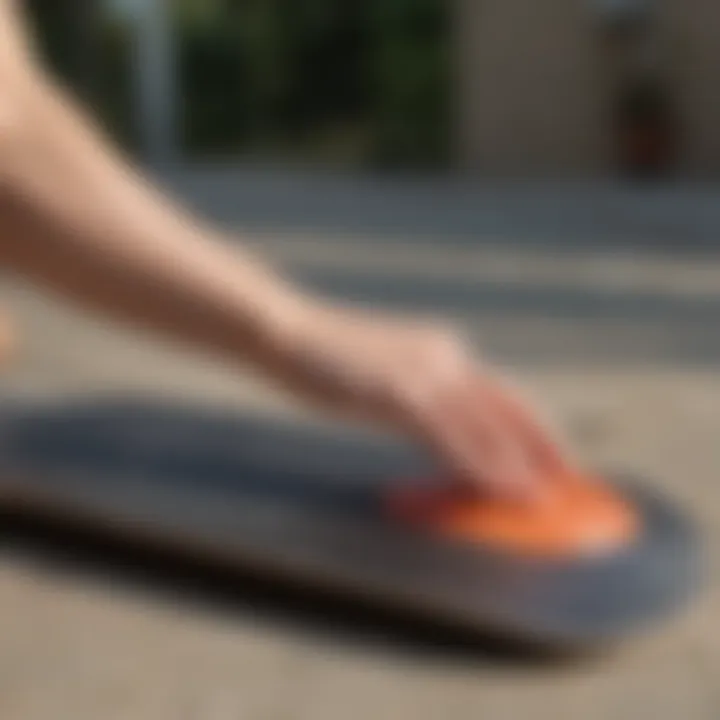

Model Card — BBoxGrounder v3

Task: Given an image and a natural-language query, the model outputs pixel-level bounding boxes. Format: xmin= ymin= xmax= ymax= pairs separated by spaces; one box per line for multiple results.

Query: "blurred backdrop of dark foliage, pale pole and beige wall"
xmin=22 ymin=0 xmax=720 ymax=179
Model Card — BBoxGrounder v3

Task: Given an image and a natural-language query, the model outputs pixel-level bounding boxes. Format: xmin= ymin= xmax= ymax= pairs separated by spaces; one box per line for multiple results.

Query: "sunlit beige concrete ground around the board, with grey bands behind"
xmin=0 ymin=177 xmax=720 ymax=720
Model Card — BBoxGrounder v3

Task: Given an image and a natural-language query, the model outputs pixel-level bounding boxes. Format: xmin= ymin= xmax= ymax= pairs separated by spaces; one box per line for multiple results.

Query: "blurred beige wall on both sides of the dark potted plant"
xmin=454 ymin=0 xmax=720 ymax=178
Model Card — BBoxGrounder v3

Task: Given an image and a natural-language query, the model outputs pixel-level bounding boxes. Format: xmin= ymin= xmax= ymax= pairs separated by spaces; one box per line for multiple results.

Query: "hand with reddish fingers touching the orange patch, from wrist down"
xmin=262 ymin=306 xmax=564 ymax=496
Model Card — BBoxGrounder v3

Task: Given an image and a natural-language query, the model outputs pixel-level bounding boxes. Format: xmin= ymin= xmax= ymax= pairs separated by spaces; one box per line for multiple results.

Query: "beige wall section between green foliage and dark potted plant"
xmin=456 ymin=0 xmax=609 ymax=176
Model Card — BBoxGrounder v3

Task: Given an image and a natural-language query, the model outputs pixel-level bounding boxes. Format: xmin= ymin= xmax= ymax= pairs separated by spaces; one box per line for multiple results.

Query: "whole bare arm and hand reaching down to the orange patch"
xmin=0 ymin=0 xmax=564 ymax=496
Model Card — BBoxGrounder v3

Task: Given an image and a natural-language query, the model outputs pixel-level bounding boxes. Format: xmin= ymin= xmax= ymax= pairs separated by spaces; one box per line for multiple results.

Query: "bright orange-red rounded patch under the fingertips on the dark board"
xmin=386 ymin=472 xmax=639 ymax=558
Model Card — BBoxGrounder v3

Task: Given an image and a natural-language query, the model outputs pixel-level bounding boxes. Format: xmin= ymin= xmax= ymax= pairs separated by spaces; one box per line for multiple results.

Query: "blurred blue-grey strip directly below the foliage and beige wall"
xmin=163 ymin=167 xmax=720 ymax=251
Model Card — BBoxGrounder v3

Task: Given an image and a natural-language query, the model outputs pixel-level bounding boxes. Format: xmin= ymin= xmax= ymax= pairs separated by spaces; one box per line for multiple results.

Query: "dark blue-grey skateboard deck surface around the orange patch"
xmin=0 ymin=400 xmax=699 ymax=648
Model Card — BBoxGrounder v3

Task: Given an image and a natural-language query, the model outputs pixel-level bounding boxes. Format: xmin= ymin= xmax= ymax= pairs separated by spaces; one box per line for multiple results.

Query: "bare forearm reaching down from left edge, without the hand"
xmin=0 ymin=61 xmax=301 ymax=366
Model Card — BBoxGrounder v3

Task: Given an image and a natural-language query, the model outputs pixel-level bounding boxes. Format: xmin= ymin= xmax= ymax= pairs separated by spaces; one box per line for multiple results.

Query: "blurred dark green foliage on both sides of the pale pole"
xmin=29 ymin=0 xmax=451 ymax=167
